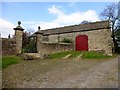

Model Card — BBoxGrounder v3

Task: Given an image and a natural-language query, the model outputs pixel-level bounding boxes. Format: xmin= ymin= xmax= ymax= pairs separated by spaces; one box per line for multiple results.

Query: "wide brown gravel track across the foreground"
xmin=2 ymin=58 xmax=118 ymax=88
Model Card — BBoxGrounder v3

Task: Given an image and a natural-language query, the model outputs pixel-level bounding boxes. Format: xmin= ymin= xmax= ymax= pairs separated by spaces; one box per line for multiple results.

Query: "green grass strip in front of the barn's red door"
xmin=50 ymin=51 xmax=113 ymax=59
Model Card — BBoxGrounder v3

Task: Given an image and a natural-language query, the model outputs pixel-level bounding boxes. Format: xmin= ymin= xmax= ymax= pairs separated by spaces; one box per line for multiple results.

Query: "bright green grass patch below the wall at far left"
xmin=2 ymin=56 xmax=22 ymax=69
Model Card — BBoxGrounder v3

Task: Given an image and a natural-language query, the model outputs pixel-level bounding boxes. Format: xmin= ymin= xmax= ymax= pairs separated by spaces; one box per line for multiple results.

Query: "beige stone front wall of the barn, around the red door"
xmin=41 ymin=29 xmax=113 ymax=55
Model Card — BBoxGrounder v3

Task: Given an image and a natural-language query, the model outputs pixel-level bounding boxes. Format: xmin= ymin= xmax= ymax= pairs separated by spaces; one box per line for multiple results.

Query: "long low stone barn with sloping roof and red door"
xmin=34 ymin=21 xmax=113 ymax=55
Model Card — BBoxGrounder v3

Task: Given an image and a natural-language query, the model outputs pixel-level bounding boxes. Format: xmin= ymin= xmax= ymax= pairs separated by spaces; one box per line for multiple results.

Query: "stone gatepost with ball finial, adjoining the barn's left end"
xmin=35 ymin=26 xmax=43 ymax=56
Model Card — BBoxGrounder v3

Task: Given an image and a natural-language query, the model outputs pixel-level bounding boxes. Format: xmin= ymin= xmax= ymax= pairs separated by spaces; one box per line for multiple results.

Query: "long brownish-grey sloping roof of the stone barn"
xmin=36 ymin=20 xmax=110 ymax=35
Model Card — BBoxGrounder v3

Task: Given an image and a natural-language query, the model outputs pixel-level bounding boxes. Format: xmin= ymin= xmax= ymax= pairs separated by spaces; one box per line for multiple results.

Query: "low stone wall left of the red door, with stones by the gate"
xmin=23 ymin=42 xmax=74 ymax=60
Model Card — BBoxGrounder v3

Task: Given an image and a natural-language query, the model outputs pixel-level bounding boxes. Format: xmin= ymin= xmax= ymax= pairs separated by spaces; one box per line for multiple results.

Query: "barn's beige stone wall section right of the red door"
xmin=77 ymin=29 xmax=113 ymax=55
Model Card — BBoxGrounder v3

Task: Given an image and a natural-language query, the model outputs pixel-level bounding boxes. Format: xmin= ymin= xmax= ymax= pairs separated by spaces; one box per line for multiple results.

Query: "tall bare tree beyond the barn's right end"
xmin=100 ymin=3 xmax=118 ymax=52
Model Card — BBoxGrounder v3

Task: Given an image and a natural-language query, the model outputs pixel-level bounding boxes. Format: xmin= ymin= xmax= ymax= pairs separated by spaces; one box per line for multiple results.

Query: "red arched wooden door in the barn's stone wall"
xmin=76 ymin=35 xmax=88 ymax=51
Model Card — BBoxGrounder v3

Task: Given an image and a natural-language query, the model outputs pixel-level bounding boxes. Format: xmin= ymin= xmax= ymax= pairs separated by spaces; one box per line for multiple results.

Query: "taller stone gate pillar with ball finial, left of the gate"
xmin=13 ymin=21 xmax=24 ymax=54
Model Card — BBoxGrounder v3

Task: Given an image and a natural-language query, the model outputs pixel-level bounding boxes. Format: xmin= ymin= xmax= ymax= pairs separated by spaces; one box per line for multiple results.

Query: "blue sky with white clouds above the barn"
xmin=0 ymin=2 xmax=119 ymax=37
